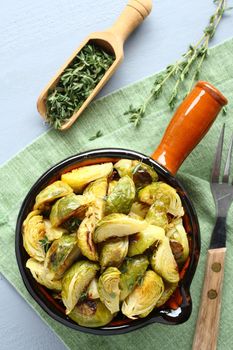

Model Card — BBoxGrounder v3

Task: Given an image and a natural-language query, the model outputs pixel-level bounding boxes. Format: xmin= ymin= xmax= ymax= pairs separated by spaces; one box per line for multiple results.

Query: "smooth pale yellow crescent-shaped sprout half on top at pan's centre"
xmin=94 ymin=213 xmax=148 ymax=243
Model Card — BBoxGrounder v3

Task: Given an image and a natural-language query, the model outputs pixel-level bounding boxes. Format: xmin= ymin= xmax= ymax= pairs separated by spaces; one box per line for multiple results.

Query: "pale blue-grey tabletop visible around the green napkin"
xmin=0 ymin=0 xmax=233 ymax=350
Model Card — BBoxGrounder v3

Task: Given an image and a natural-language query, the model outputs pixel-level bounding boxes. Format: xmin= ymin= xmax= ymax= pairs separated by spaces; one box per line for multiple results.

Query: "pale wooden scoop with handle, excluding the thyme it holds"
xmin=37 ymin=0 xmax=152 ymax=130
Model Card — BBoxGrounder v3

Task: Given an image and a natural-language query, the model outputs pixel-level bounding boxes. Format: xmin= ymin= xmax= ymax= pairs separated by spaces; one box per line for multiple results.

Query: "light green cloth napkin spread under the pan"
xmin=0 ymin=39 xmax=233 ymax=350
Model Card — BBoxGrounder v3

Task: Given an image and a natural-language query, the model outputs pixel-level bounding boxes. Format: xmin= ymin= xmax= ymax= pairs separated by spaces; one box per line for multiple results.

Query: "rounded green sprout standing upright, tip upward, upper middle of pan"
xmin=106 ymin=176 xmax=136 ymax=214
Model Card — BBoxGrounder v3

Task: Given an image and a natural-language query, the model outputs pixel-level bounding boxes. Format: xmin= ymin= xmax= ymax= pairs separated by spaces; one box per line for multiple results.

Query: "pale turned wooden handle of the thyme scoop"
xmin=108 ymin=0 xmax=152 ymax=43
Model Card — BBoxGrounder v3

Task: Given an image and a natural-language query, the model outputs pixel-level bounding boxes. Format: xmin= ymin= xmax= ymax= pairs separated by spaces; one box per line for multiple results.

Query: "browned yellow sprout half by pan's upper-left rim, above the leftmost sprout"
xmin=34 ymin=180 xmax=73 ymax=210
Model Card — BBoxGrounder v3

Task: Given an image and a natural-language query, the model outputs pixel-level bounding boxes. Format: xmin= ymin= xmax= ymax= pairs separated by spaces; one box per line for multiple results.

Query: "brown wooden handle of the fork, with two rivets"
xmin=192 ymin=248 xmax=226 ymax=350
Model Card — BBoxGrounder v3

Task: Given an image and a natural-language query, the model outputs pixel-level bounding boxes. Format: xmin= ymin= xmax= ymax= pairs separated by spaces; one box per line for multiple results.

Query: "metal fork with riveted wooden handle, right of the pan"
xmin=193 ymin=124 xmax=233 ymax=350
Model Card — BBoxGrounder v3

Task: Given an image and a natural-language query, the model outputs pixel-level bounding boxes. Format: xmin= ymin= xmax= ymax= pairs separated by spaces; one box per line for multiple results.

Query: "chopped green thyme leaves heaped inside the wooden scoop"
xmin=46 ymin=44 xmax=115 ymax=129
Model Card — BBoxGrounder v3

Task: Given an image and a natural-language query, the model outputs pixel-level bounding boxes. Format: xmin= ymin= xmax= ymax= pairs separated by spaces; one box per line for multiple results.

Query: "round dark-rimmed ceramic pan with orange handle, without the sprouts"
xmin=15 ymin=82 xmax=227 ymax=335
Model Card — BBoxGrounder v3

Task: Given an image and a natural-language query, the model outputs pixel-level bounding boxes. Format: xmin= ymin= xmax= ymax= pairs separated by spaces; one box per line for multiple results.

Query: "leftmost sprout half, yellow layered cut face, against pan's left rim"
xmin=23 ymin=210 xmax=45 ymax=261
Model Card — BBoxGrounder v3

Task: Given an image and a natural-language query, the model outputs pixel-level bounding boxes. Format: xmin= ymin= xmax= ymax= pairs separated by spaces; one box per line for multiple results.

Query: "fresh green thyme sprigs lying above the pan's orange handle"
xmin=124 ymin=0 xmax=231 ymax=127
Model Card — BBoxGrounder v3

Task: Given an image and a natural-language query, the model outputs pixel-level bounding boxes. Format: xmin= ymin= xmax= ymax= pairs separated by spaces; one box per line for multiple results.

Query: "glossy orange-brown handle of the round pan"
xmin=152 ymin=81 xmax=228 ymax=175
